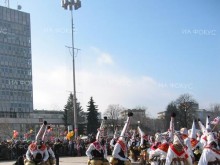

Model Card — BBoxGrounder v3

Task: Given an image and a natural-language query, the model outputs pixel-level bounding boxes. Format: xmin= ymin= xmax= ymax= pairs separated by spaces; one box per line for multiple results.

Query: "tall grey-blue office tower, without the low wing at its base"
xmin=0 ymin=6 xmax=33 ymax=118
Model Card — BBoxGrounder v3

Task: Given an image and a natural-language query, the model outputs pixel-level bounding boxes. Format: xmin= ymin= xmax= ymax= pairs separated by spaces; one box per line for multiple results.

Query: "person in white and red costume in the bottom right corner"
xmin=198 ymin=133 xmax=220 ymax=165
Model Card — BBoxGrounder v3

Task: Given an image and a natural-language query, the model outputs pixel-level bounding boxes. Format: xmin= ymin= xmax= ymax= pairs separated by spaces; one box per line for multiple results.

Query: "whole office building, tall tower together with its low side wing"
xmin=0 ymin=6 xmax=63 ymax=137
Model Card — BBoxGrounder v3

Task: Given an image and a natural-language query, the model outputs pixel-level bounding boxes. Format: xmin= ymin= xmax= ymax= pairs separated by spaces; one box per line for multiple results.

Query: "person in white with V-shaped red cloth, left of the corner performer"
xmin=165 ymin=134 xmax=193 ymax=165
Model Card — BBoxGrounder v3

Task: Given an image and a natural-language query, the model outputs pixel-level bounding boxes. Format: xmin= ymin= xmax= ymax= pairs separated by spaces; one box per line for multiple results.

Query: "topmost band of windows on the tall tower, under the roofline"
xmin=0 ymin=6 xmax=30 ymax=25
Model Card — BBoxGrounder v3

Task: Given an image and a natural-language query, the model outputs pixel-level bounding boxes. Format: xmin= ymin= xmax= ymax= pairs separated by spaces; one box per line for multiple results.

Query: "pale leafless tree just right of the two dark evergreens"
xmin=104 ymin=104 xmax=125 ymax=134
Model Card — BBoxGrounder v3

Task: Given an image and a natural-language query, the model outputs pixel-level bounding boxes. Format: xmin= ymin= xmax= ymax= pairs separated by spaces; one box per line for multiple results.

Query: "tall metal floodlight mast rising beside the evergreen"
xmin=61 ymin=0 xmax=81 ymax=138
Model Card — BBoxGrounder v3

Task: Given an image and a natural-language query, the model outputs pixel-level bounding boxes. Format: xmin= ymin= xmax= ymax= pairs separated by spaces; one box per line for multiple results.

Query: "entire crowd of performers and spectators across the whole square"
xmin=0 ymin=112 xmax=220 ymax=165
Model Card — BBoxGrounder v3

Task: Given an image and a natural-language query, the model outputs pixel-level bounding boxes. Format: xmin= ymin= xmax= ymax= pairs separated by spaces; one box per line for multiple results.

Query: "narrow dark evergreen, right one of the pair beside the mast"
xmin=87 ymin=97 xmax=100 ymax=134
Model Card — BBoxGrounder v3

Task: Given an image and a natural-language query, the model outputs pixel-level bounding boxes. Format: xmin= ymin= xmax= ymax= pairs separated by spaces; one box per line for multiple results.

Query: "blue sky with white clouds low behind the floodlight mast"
xmin=4 ymin=0 xmax=220 ymax=117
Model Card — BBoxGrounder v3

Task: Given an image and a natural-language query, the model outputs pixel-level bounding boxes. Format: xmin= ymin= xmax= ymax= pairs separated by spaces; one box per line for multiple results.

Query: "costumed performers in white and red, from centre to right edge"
xmin=86 ymin=113 xmax=220 ymax=165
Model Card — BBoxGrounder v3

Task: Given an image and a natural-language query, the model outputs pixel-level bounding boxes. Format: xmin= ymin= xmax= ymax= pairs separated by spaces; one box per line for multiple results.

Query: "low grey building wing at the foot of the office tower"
xmin=0 ymin=110 xmax=64 ymax=139
